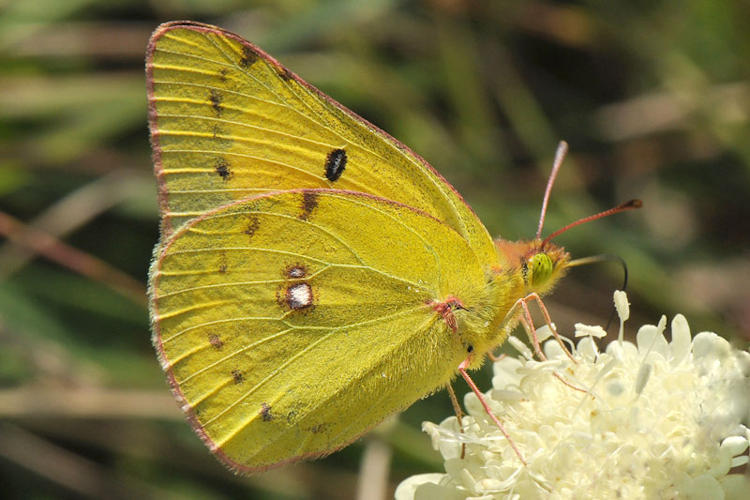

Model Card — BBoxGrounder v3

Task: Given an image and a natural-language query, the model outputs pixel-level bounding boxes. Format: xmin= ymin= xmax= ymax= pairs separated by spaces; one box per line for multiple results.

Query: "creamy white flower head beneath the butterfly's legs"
xmin=396 ymin=292 xmax=750 ymax=500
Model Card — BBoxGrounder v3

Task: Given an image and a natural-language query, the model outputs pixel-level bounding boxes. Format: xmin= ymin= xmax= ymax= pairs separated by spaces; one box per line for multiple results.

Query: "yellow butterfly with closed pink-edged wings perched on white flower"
xmin=146 ymin=22 xmax=636 ymax=472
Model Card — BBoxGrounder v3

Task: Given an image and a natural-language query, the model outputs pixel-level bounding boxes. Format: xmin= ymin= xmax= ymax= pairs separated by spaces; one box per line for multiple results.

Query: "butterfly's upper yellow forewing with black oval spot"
xmin=146 ymin=22 xmax=497 ymax=265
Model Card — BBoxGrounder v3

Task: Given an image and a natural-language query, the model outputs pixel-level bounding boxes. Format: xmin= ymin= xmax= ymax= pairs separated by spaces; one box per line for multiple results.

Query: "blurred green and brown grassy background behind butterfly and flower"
xmin=0 ymin=0 xmax=750 ymax=499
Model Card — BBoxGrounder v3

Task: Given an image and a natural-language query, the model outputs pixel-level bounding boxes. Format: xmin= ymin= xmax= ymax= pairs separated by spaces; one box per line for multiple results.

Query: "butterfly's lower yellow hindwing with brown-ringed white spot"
xmin=150 ymin=190 xmax=485 ymax=472
